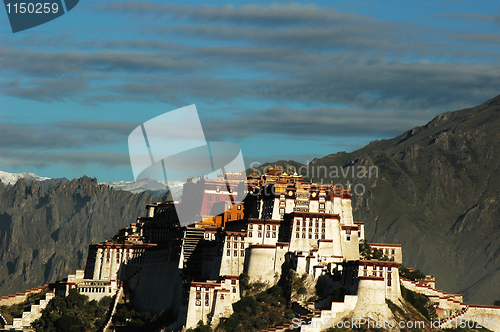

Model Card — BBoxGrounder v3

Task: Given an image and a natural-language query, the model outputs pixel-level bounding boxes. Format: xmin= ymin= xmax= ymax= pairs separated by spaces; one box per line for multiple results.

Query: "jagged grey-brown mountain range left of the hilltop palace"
xmin=0 ymin=177 xmax=153 ymax=296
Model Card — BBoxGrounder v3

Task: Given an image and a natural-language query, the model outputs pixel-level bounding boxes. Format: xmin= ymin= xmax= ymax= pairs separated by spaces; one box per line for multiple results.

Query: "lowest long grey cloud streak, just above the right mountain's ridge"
xmin=202 ymin=107 xmax=423 ymax=141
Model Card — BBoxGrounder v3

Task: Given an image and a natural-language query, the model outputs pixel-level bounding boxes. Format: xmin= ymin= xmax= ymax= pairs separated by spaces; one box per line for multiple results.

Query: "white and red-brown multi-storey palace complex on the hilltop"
xmin=0 ymin=167 xmax=500 ymax=331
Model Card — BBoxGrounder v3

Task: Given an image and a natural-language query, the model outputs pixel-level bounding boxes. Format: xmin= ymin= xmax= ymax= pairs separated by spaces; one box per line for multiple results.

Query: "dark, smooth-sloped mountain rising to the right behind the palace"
xmin=302 ymin=96 xmax=500 ymax=304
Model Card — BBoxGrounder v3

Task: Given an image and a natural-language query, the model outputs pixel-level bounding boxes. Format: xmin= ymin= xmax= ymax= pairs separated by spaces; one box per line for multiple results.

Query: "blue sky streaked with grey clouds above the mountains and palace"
xmin=0 ymin=0 xmax=500 ymax=181
